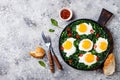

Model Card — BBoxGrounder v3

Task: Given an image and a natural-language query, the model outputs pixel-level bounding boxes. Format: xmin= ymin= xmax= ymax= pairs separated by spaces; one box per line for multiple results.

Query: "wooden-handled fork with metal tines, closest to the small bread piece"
xmin=42 ymin=32 xmax=54 ymax=73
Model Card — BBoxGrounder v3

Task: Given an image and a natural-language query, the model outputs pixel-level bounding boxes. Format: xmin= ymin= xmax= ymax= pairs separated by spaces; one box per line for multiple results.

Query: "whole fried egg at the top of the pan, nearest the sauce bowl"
xmin=76 ymin=23 xmax=94 ymax=35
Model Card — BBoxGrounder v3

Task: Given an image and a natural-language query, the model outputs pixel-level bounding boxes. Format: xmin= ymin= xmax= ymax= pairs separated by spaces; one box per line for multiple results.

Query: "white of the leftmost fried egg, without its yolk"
xmin=62 ymin=38 xmax=76 ymax=57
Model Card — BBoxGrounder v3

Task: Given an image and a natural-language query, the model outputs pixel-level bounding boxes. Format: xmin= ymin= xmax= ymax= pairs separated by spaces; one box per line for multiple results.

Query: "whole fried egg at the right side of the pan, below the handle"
xmin=94 ymin=37 xmax=108 ymax=53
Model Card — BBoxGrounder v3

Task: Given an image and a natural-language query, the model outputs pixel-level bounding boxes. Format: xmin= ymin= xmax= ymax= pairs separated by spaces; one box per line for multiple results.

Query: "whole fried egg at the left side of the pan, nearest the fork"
xmin=62 ymin=38 xmax=76 ymax=57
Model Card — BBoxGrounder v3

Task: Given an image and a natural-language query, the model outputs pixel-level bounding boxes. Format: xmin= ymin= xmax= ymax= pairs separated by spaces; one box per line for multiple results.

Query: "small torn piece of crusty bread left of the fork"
xmin=30 ymin=47 xmax=45 ymax=58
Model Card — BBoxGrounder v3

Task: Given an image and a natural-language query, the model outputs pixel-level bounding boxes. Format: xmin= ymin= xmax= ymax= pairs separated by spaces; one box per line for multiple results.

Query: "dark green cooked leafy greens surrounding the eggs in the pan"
xmin=59 ymin=20 xmax=111 ymax=70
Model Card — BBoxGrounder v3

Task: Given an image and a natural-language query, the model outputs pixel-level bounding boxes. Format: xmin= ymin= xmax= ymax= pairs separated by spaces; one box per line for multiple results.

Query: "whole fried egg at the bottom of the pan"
xmin=79 ymin=52 xmax=97 ymax=66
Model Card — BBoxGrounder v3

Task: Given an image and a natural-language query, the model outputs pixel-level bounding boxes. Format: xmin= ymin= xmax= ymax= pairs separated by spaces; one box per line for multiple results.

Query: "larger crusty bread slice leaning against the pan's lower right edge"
xmin=103 ymin=53 xmax=115 ymax=76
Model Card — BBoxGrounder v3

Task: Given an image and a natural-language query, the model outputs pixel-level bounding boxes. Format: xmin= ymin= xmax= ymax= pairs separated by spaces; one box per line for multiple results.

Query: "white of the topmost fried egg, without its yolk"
xmin=76 ymin=23 xmax=93 ymax=35
